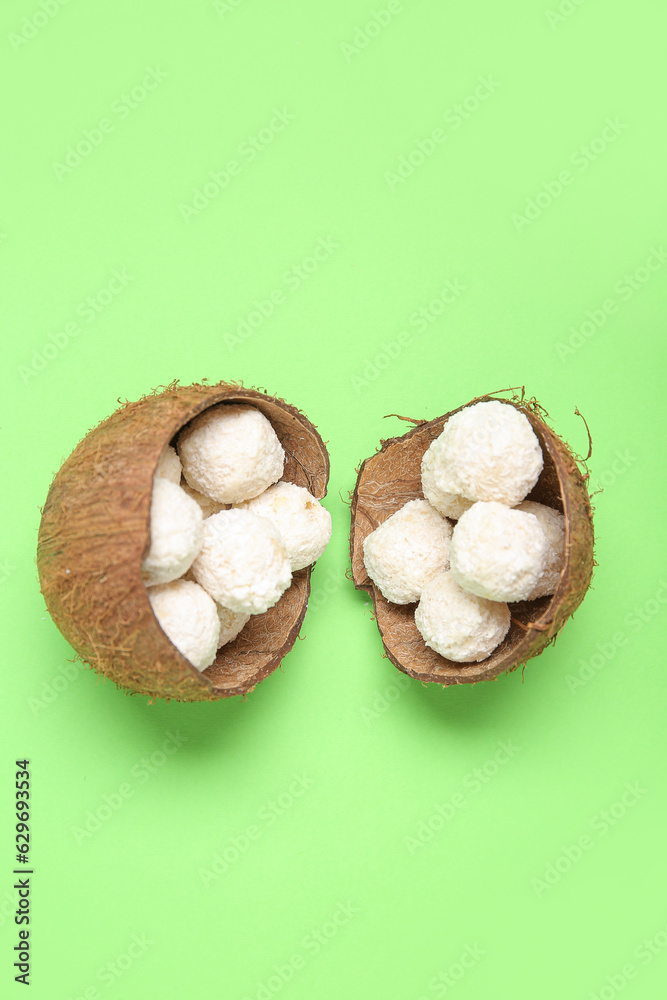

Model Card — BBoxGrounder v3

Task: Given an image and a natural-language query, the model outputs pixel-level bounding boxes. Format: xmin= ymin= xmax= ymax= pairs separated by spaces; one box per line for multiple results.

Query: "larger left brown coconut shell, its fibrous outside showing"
xmin=37 ymin=382 xmax=329 ymax=701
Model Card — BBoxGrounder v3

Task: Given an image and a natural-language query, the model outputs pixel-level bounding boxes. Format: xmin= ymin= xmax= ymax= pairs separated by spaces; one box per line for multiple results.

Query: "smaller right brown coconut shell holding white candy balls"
xmin=350 ymin=395 xmax=594 ymax=685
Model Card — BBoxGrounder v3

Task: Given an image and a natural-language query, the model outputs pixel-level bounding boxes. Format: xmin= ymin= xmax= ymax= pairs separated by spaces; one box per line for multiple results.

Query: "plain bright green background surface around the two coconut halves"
xmin=0 ymin=0 xmax=667 ymax=1000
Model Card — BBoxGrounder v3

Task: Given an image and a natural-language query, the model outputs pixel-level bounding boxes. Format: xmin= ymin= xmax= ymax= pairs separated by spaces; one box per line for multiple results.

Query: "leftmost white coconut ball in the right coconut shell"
xmin=364 ymin=500 xmax=452 ymax=604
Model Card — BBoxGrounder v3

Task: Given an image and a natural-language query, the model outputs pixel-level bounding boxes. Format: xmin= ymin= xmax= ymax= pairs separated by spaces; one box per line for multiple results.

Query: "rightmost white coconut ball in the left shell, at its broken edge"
xmin=236 ymin=483 xmax=331 ymax=572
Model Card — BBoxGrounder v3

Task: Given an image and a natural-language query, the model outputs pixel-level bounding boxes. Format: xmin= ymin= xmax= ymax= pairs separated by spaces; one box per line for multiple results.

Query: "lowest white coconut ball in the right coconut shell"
xmin=415 ymin=570 xmax=510 ymax=663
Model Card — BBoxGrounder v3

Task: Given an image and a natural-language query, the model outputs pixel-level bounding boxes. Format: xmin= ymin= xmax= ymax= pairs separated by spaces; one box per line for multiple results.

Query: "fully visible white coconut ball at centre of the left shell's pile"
xmin=192 ymin=508 xmax=292 ymax=615
